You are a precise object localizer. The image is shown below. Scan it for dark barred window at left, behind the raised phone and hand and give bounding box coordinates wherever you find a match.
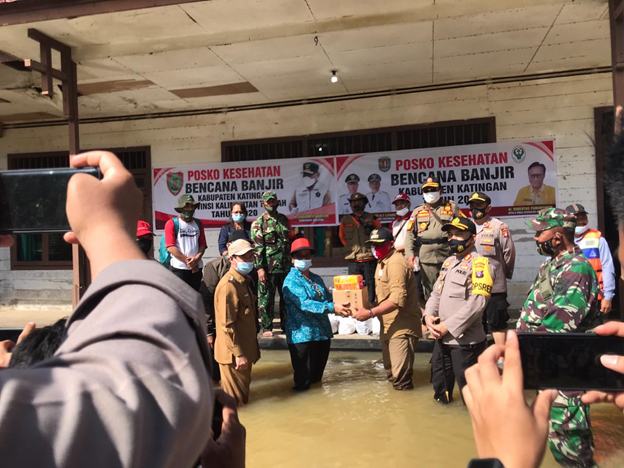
[8,148,152,270]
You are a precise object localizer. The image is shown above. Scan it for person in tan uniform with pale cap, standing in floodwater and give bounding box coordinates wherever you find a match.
[214,239,260,405]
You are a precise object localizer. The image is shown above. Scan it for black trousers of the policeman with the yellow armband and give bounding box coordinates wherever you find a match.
[431,340,486,403]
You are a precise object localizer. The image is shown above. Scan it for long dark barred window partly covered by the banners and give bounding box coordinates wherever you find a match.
[221,117,496,267]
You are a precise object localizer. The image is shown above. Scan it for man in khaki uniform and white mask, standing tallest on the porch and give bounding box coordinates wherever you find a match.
[405,177,459,301]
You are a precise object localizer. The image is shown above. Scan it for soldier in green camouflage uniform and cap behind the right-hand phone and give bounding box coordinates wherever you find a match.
[517,208,600,467]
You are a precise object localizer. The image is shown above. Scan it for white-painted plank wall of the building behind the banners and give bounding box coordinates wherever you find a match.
[0,74,613,308]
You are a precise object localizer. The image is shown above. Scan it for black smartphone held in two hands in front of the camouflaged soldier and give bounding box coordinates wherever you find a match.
[518,333,624,391]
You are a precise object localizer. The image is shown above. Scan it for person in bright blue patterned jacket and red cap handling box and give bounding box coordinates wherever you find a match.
[283,239,350,390]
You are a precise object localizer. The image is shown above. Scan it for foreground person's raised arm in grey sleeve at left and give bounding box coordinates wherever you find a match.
[0,151,213,467]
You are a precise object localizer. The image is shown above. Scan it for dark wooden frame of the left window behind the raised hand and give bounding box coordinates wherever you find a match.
[7,146,153,271]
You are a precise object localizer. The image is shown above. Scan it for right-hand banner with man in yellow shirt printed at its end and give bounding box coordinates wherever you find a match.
[336,140,557,222]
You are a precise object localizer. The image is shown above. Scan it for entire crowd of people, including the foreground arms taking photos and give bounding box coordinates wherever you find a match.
[0,134,624,468]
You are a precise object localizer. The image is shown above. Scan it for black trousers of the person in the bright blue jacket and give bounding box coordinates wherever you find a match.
[288,340,330,390]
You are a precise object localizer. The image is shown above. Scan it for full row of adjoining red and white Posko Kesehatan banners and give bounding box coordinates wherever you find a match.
[153,140,557,230]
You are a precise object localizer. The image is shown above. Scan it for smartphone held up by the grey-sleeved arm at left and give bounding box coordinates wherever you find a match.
[0,167,102,234]
